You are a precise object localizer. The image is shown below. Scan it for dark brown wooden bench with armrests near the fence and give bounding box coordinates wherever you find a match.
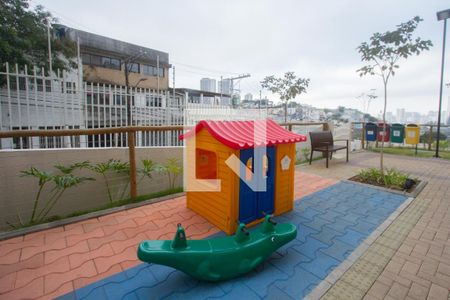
[309,131,348,168]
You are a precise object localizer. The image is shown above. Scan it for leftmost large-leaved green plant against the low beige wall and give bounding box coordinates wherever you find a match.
[18,162,94,226]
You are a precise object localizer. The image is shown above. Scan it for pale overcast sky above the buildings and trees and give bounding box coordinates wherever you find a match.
[31,0,450,114]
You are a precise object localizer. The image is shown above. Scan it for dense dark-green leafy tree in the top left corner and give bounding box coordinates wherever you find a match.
[0,0,76,70]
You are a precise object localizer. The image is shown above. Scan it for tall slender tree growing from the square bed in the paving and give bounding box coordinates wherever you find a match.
[356,16,433,174]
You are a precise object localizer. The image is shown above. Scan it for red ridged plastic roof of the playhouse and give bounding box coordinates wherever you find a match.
[180,119,306,149]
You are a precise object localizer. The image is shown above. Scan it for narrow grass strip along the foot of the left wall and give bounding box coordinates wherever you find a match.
[10,187,183,229]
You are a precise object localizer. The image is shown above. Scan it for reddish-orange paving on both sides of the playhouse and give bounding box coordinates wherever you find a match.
[0,172,336,299]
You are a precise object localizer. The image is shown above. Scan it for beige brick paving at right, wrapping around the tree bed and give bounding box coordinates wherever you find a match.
[302,152,450,300]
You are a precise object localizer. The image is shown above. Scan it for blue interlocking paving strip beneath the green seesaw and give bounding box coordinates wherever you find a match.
[59,182,406,300]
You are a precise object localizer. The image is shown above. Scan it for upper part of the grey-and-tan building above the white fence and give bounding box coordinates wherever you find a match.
[57,25,170,90]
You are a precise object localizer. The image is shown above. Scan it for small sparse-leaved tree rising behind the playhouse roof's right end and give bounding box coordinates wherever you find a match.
[261,72,309,122]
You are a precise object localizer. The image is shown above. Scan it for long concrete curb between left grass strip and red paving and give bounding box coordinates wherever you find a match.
[0,192,186,241]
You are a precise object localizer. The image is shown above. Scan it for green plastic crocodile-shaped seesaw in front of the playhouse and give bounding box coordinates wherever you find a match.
[137,215,297,281]
